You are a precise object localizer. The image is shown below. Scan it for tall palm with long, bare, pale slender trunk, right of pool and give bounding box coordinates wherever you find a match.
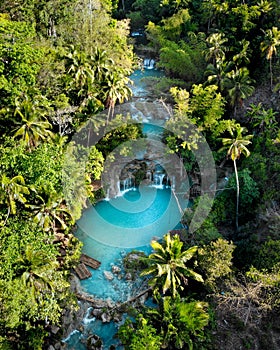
[222,125,253,230]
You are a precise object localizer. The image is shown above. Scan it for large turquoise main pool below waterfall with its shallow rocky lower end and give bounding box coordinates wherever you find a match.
[77,187,187,301]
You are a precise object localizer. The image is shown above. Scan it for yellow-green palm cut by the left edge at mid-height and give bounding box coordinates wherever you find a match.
[0,174,29,225]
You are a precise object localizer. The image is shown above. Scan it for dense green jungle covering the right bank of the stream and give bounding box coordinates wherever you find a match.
[116,0,280,350]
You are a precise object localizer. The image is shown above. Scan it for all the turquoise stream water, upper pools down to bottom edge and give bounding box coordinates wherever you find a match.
[64,61,188,350]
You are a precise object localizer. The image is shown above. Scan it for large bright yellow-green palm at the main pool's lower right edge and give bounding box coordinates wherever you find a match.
[141,233,203,297]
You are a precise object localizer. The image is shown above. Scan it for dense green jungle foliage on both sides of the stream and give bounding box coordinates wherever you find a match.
[0,0,280,350]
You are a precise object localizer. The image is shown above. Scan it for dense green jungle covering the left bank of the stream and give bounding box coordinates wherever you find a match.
[0,1,138,349]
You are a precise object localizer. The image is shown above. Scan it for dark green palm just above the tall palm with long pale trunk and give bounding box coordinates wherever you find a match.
[224,67,254,117]
